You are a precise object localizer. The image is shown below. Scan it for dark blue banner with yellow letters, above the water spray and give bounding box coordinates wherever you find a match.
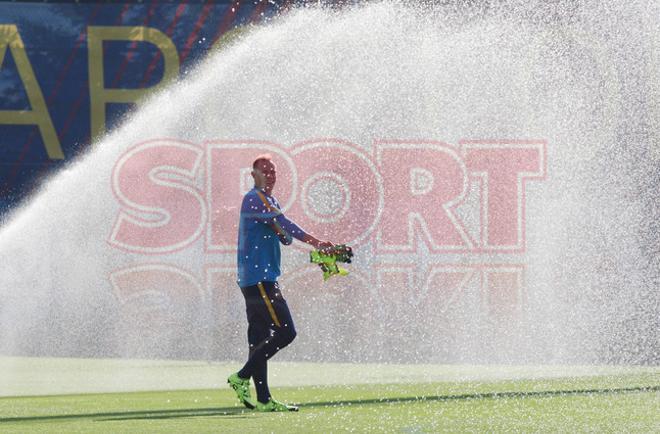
[0,1,287,215]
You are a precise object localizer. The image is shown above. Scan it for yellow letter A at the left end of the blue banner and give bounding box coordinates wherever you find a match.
[0,24,64,160]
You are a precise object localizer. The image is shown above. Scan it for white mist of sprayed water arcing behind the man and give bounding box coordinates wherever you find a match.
[0,0,660,364]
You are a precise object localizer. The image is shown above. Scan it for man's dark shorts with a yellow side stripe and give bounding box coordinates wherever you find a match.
[241,282,296,347]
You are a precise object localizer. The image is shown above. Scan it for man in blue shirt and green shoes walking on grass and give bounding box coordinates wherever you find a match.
[227,155,333,411]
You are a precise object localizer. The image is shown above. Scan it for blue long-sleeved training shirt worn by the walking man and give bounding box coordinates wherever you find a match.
[237,187,306,287]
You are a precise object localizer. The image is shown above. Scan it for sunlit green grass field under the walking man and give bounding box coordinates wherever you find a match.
[0,358,660,433]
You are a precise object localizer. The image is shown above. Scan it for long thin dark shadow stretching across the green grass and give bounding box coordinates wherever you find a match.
[0,386,660,424]
